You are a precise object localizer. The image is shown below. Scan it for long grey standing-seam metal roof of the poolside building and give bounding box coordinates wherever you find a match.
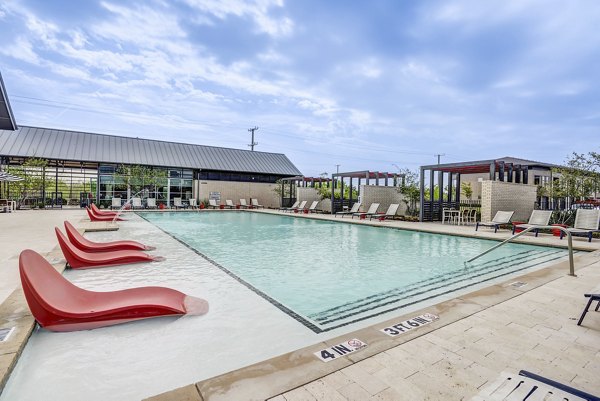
[0,126,302,176]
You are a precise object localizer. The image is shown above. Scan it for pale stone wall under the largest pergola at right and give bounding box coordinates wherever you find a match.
[481,180,537,221]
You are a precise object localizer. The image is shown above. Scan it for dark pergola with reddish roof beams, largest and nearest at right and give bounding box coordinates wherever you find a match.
[420,158,554,221]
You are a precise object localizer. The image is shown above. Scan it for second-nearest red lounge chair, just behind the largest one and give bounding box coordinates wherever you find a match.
[54,227,165,269]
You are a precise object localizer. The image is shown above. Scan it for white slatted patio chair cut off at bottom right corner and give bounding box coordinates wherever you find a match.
[471,370,600,401]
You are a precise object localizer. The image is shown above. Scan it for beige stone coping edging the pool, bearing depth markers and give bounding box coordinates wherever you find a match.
[145,211,600,401]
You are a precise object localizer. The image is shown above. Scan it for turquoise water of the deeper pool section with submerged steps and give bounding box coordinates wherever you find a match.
[142,212,567,333]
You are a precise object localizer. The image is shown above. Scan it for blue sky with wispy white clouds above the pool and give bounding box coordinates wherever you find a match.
[0,0,600,177]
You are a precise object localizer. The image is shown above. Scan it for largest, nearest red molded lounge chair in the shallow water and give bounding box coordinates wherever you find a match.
[19,249,208,331]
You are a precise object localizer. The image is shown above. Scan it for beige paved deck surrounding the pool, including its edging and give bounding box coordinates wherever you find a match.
[0,210,600,401]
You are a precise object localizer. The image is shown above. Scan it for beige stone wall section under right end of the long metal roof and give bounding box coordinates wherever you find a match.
[194,180,281,208]
